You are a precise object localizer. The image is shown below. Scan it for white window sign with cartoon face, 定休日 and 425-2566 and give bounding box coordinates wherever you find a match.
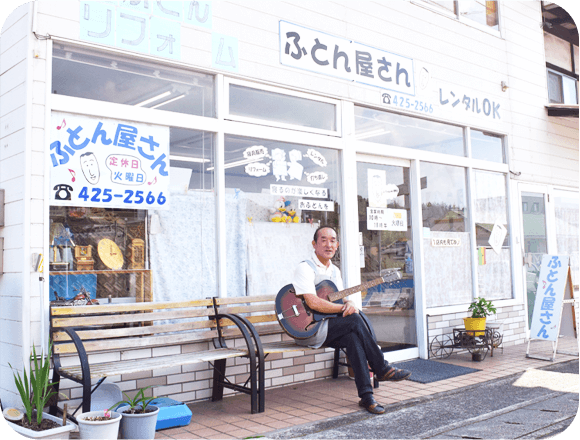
[50,112,169,209]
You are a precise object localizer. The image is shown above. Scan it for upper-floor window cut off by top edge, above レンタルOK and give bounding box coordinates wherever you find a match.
[415,0,499,30]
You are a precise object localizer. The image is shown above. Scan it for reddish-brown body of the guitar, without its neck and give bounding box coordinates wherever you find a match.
[276,280,342,339]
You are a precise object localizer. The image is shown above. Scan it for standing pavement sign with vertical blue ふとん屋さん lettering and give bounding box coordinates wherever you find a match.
[530,255,570,342]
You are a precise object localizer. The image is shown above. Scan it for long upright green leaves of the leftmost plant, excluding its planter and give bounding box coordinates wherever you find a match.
[8,341,56,425]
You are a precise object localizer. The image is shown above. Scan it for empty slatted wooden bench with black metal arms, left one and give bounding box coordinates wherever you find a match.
[50,299,264,414]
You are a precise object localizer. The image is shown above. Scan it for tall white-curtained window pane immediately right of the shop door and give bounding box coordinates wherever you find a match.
[421,162,473,307]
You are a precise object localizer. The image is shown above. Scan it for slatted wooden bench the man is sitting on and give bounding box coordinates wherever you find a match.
[213,295,379,412]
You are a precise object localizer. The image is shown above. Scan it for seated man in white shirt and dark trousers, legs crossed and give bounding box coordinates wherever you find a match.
[292,226,411,414]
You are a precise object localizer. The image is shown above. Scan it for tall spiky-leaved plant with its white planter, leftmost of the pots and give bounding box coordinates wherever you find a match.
[4,342,76,440]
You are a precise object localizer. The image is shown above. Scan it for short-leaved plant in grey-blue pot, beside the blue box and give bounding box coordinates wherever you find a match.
[111,386,159,440]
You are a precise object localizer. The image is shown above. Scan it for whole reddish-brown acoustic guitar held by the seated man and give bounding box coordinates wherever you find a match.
[276,269,402,339]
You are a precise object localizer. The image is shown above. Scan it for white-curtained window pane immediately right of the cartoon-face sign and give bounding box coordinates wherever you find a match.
[150,127,217,301]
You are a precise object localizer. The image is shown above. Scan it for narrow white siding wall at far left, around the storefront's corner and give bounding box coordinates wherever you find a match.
[0,4,31,405]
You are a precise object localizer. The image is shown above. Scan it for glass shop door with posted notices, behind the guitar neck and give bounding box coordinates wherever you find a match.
[357,156,418,360]
